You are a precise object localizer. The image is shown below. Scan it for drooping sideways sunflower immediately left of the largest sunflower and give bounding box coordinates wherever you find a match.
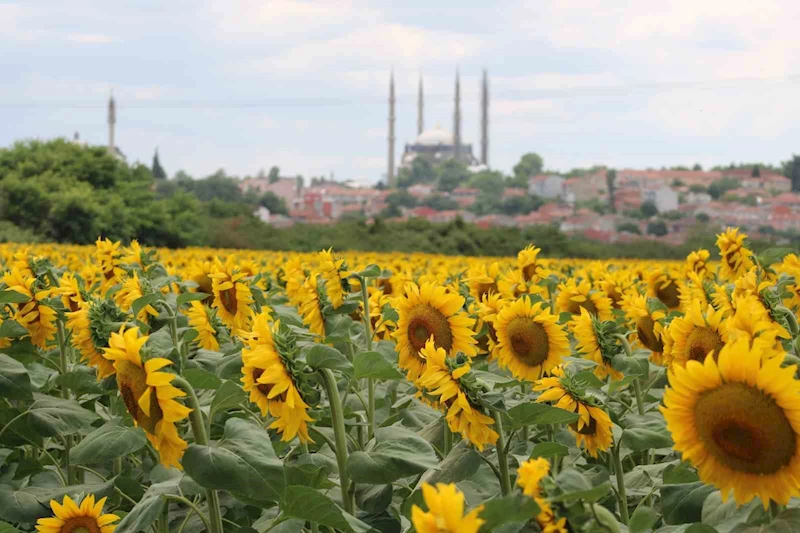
[533,366,613,458]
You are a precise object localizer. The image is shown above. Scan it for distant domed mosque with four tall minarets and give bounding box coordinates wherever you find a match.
[386,69,489,187]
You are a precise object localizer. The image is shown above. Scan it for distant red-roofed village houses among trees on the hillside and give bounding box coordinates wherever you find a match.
[240,165,800,244]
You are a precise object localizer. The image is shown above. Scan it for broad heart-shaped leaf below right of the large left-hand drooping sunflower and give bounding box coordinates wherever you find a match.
[183,418,286,502]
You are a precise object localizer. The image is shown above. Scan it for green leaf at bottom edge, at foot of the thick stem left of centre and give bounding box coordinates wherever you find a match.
[281,486,377,533]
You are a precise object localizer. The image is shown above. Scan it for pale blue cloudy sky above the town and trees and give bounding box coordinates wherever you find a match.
[0,0,800,183]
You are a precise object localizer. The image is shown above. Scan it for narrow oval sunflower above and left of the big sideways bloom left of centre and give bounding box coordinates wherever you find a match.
[211,258,253,335]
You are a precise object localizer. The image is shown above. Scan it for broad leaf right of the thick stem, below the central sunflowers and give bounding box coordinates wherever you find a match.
[347,426,439,485]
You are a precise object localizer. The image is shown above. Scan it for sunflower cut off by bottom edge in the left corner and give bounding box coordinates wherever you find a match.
[36,494,119,533]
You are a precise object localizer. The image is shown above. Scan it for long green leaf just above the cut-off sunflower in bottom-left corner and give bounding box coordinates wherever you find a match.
[0,478,114,524]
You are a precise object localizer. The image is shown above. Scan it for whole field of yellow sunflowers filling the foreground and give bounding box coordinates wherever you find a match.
[0,229,800,533]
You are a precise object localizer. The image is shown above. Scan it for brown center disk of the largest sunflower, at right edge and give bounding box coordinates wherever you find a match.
[694,383,796,475]
